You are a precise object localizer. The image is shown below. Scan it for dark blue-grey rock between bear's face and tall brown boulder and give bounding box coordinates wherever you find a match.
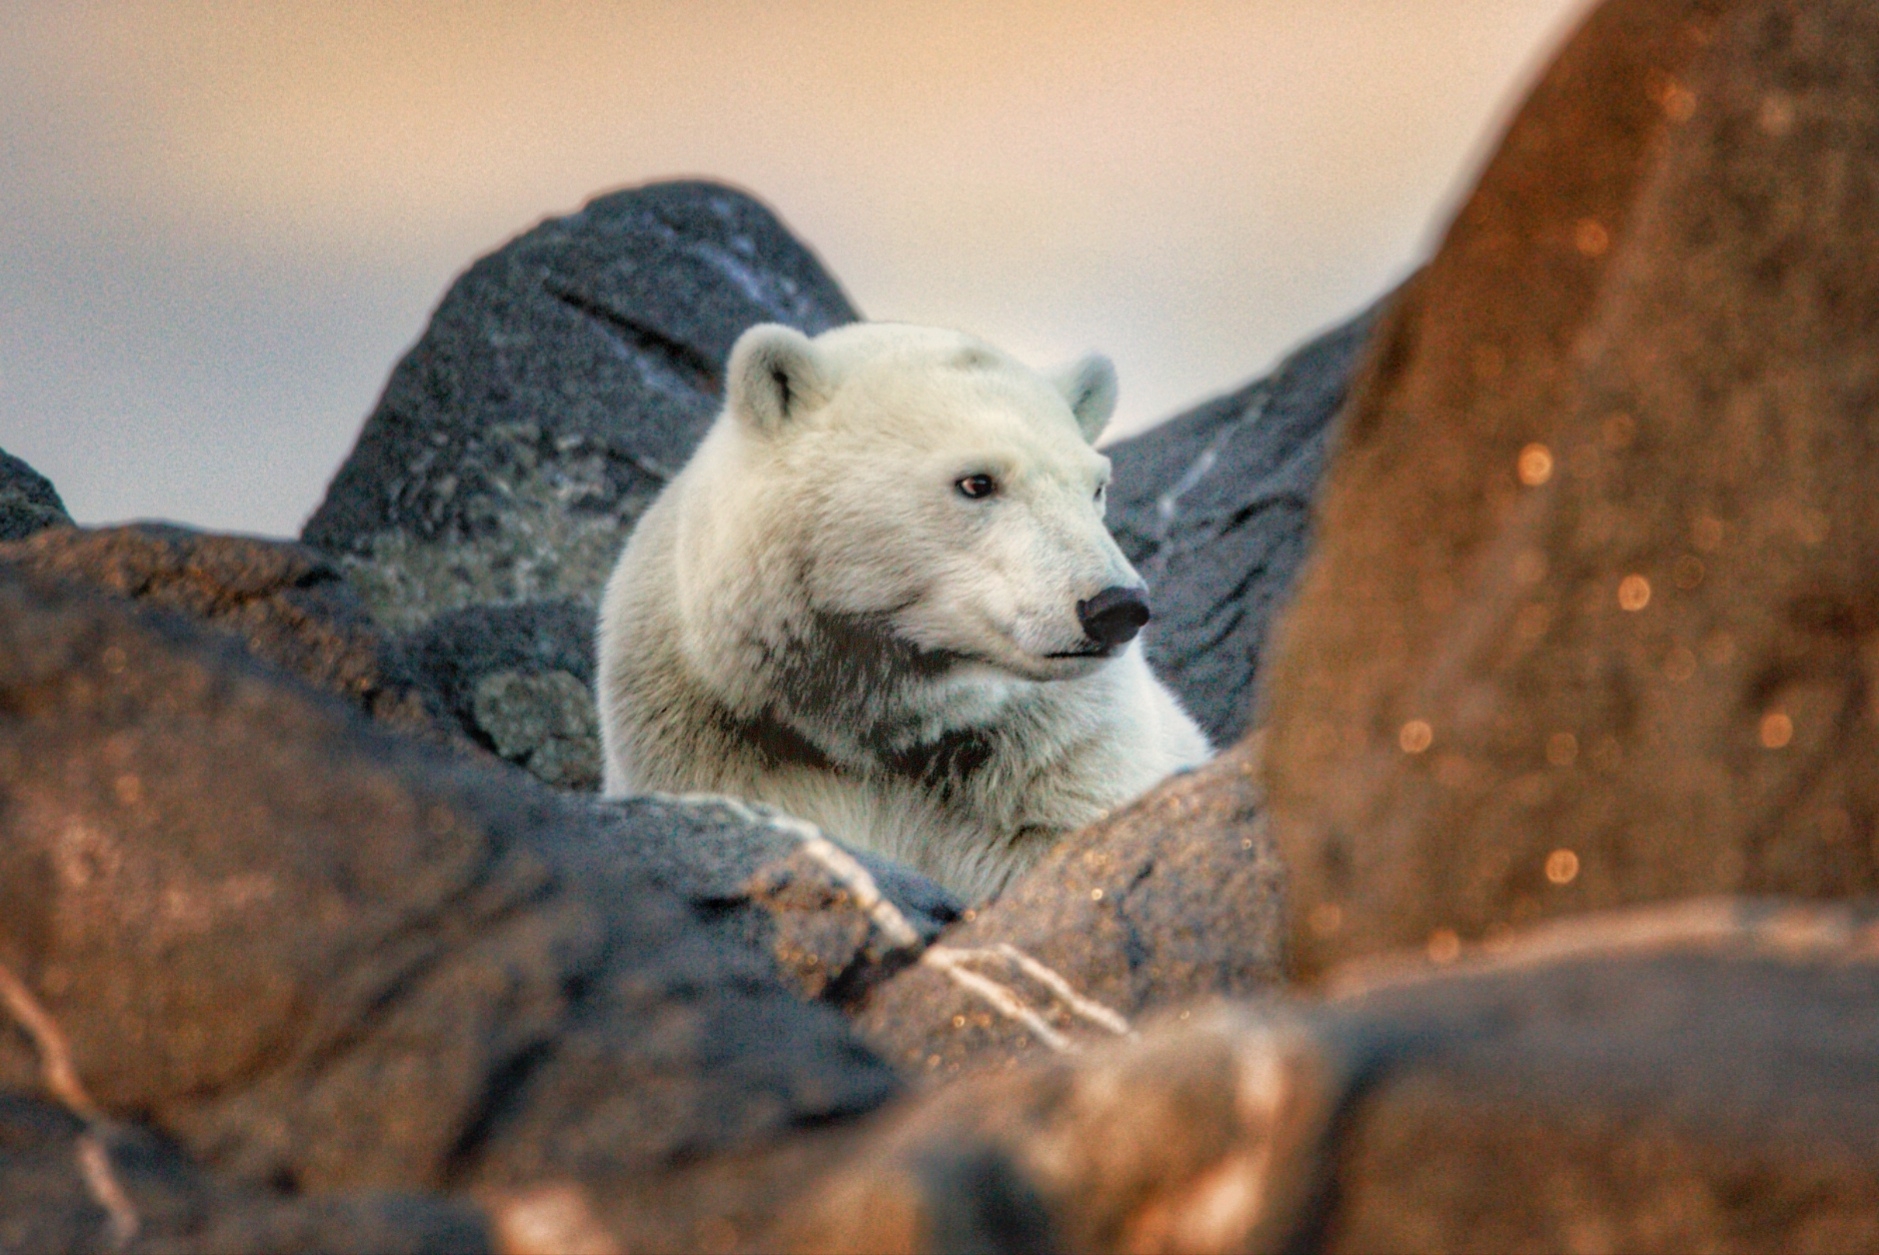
[1105,308,1377,746]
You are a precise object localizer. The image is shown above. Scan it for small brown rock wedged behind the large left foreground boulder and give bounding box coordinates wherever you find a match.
[0,522,451,740]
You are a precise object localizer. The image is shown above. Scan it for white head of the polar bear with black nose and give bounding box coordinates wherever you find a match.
[678,323,1148,751]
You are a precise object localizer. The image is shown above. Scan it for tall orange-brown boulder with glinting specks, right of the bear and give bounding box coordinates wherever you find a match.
[1265,0,1879,977]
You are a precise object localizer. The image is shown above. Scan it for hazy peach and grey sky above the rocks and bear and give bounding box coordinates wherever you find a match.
[0,0,1584,535]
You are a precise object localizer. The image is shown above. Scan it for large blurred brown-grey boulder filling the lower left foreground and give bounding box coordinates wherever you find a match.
[0,569,913,1249]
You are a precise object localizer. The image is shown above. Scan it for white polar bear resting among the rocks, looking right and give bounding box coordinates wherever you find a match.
[596,323,1210,900]
